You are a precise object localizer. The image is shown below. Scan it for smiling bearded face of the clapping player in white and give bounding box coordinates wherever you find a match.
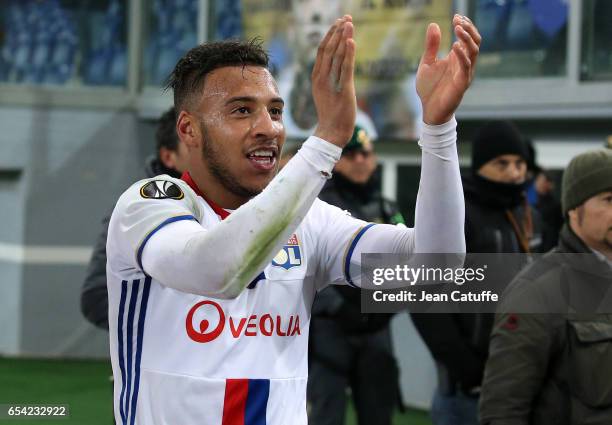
[198,66,285,199]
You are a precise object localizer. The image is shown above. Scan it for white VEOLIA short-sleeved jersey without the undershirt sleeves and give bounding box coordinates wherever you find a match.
[107,176,365,425]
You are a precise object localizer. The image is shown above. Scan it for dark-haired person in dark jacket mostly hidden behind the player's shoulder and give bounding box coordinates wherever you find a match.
[81,107,187,330]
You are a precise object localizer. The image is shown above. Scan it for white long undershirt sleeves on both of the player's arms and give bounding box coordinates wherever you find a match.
[142,114,465,298]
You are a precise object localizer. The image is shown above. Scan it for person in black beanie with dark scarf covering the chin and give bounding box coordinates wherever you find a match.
[412,121,542,425]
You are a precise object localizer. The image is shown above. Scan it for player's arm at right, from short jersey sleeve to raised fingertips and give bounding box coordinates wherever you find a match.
[314,15,481,286]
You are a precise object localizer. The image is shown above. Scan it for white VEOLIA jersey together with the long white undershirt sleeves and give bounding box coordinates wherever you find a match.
[107,120,465,425]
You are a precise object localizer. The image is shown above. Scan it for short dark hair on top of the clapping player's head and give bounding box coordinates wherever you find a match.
[166,38,269,111]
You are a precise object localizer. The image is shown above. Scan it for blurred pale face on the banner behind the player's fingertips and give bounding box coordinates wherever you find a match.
[291,0,342,61]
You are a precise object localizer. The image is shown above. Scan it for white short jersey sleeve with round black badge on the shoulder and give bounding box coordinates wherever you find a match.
[106,175,202,270]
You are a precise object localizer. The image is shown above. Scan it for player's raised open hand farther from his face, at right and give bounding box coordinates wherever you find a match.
[416,15,481,125]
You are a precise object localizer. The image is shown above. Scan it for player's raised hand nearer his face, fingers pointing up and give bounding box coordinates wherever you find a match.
[312,15,357,148]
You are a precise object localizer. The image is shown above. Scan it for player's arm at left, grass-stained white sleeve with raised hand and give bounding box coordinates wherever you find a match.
[114,16,356,298]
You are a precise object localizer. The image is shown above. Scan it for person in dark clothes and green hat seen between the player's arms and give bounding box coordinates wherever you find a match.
[307,125,404,425]
